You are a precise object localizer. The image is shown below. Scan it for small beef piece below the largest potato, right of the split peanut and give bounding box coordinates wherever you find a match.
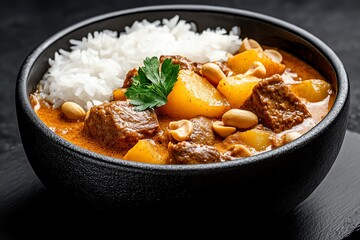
[189,116,215,145]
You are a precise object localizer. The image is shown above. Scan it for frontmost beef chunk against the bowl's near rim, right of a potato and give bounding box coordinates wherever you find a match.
[168,141,230,164]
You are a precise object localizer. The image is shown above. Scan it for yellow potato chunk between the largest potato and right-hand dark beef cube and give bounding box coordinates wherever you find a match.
[217,74,260,108]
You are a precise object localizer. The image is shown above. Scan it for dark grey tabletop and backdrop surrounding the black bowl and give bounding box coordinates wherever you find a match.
[0,0,360,239]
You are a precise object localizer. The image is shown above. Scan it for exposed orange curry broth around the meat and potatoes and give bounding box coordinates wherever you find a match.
[36,50,335,161]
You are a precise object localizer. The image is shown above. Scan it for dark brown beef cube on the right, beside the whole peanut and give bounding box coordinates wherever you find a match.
[240,74,311,133]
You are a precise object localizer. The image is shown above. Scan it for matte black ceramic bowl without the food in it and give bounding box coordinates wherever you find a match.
[16,5,349,213]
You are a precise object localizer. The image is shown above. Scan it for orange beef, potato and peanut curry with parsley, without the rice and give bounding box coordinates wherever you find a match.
[30,15,336,164]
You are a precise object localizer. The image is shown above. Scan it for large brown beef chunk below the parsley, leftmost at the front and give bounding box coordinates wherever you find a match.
[84,101,159,149]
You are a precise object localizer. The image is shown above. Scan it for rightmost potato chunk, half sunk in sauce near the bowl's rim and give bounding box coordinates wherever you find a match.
[289,79,332,102]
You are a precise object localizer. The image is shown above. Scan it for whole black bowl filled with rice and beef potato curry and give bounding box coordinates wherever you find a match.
[16,5,349,212]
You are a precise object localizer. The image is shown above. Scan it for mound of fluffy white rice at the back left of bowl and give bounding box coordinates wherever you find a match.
[37,16,241,110]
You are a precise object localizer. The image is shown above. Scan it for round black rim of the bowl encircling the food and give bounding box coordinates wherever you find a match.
[16,4,349,172]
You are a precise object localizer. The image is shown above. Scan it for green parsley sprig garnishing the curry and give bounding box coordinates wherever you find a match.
[125,57,180,111]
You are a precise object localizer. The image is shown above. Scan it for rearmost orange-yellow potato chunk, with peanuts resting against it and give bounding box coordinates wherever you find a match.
[228,49,285,77]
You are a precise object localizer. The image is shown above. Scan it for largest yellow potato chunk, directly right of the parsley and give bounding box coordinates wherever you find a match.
[158,70,230,119]
